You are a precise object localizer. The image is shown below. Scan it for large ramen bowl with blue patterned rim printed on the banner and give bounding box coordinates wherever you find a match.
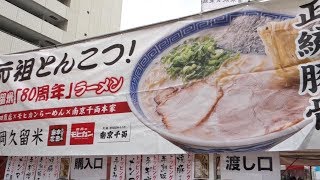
[128,11,310,152]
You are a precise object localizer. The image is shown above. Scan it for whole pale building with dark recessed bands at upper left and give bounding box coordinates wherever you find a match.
[0,0,122,54]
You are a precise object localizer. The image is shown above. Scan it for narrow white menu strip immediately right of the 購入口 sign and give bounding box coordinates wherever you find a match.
[110,156,126,180]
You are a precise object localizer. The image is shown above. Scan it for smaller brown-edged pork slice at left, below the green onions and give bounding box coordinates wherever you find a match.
[157,81,222,132]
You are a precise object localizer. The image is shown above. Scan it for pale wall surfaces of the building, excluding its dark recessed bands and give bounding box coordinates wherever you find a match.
[0,0,122,53]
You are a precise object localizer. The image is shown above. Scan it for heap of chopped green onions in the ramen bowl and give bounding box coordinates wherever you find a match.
[161,37,237,82]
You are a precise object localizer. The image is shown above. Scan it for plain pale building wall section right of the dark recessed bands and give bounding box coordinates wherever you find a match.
[68,0,122,40]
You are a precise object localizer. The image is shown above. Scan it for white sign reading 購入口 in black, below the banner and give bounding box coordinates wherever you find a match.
[70,156,107,180]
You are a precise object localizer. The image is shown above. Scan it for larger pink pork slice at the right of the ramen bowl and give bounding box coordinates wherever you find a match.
[208,71,309,140]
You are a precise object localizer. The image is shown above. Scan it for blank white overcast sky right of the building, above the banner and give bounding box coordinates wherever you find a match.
[121,0,201,30]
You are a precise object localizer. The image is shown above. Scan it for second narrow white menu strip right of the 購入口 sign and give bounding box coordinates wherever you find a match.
[126,155,141,180]
